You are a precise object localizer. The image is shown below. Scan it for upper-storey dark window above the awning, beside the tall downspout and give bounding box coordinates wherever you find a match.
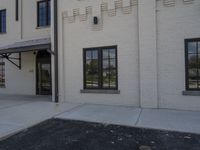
[37,0,51,27]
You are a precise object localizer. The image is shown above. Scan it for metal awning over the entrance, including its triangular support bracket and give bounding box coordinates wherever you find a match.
[0,38,54,69]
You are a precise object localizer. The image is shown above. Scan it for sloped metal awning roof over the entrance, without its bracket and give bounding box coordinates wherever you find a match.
[0,38,51,54]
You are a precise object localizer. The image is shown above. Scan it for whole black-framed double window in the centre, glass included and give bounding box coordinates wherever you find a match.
[83,46,118,89]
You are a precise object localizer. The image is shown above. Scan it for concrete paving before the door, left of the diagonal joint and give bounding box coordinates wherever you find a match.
[0,96,80,140]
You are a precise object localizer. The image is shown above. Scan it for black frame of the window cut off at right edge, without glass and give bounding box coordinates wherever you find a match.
[185,38,200,91]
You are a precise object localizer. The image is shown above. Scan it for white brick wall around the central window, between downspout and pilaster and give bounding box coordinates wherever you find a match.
[59,0,139,106]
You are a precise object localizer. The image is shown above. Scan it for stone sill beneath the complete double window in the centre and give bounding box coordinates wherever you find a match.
[80,89,120,94]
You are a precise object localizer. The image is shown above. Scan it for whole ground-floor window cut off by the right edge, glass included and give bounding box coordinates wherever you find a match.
[185,39,200,91]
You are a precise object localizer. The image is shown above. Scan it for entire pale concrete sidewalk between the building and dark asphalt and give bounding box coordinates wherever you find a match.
[0,96,200,140]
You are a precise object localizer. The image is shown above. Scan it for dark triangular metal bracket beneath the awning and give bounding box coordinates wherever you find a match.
[0,52,22,70]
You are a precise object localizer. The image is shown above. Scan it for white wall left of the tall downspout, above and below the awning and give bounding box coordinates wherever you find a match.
[0,0,51,95]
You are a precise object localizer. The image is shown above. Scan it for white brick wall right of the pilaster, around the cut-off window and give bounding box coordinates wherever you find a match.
[157,0,200,110]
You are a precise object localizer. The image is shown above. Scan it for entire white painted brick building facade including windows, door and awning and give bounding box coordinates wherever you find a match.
[0,0,200,110]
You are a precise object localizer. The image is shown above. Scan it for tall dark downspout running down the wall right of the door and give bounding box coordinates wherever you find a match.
[53,0,59,103]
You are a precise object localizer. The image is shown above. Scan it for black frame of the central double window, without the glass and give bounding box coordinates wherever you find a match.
[83,45,118,90]
